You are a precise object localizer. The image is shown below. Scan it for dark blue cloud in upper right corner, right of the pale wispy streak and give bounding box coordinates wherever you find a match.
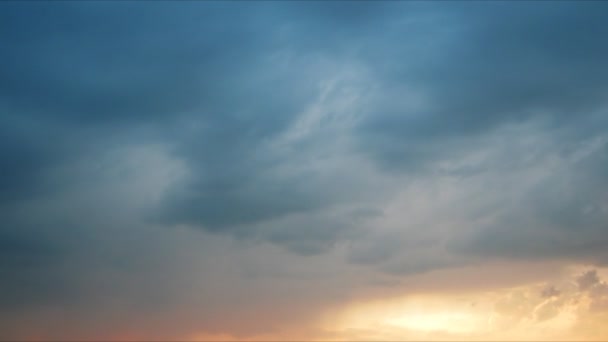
[354,3,608,169]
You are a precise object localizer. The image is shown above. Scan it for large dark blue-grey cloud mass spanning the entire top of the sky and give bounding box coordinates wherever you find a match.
[3,4,606,256]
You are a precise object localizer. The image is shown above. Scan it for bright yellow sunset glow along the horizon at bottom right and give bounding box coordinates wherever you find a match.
[326,268,608,341]
